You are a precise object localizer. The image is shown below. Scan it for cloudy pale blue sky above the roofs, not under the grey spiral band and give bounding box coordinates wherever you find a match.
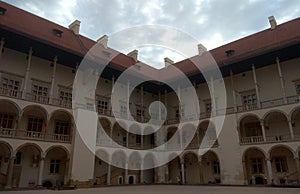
[5,0,300,68]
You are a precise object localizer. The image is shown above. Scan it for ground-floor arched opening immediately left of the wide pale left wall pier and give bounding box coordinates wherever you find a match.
[42,147,69,186]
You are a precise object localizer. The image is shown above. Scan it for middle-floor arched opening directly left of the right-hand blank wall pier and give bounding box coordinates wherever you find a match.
[198,121,218,148]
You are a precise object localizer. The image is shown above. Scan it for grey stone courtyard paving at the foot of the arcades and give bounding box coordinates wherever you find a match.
[0,185,300,194]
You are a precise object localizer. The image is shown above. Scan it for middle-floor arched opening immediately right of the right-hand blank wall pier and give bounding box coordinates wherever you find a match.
[239,115,264,144]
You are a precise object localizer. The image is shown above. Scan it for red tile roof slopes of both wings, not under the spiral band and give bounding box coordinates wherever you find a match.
[0,2,300,77]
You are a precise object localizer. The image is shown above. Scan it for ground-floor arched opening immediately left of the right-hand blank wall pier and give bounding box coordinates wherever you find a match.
[201,151,221,184]
